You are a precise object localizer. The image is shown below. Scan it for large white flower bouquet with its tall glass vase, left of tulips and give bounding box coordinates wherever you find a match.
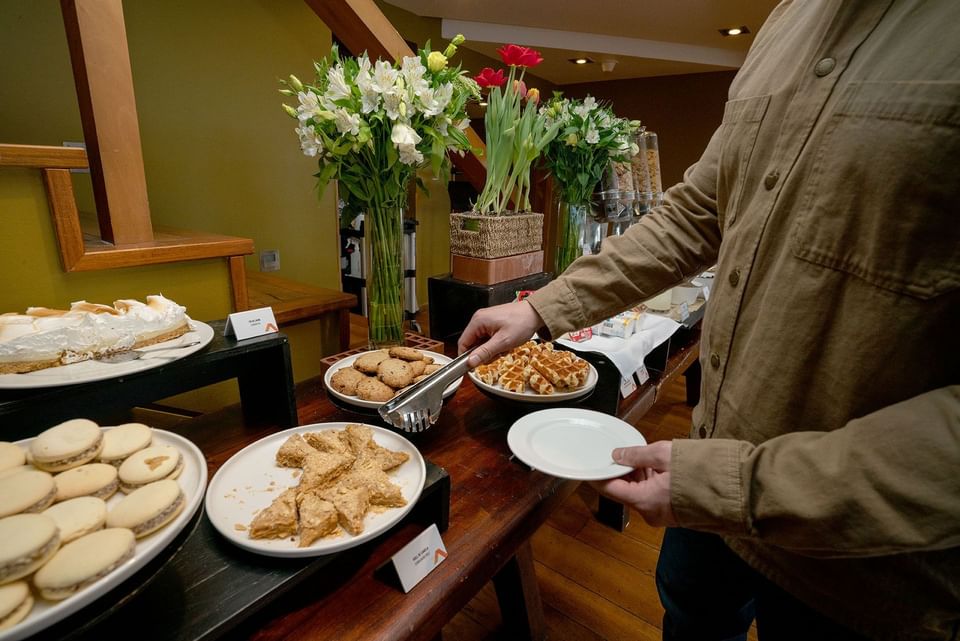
[281,36,480,346]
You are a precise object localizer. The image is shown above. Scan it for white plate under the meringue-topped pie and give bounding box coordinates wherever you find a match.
[0,320,213,389]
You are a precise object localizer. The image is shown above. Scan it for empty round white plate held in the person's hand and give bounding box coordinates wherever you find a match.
[507,407,647,481]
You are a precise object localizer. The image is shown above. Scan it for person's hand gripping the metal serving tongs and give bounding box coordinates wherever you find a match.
[457,301,543,367]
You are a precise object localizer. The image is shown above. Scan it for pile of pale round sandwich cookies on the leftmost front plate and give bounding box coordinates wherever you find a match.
[0,419,186,630]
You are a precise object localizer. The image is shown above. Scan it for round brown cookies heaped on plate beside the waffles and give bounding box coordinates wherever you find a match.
[330,347,442,403]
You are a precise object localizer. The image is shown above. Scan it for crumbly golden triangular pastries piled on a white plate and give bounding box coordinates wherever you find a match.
[249,424,410,547]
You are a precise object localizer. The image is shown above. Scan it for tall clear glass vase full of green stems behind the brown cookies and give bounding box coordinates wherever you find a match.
[363,205,404,349]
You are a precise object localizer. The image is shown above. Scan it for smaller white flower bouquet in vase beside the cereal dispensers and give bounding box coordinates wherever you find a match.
[540,93,640,274]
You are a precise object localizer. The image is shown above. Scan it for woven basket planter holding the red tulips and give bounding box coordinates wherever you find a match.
[450,213,543,258]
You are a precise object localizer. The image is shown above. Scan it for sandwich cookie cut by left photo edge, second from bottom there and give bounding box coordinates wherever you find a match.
[0,514,60,585]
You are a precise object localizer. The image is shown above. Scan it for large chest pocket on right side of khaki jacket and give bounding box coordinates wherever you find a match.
[790,82,960,299]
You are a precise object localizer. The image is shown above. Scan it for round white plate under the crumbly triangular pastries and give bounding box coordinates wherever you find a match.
[206,423,427,557]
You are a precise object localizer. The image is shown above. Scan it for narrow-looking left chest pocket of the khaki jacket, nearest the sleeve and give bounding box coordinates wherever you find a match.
[717,95,770,231]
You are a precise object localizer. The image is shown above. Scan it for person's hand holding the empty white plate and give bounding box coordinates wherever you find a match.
[591,441,677,527]
